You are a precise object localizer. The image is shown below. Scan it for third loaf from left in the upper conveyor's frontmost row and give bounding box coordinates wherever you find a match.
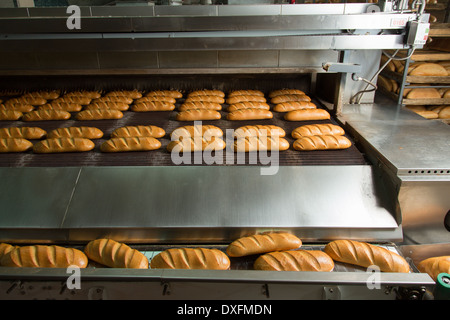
[100,137,161,152]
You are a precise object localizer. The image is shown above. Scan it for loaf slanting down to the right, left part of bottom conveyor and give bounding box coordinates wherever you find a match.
[84,239,148,269]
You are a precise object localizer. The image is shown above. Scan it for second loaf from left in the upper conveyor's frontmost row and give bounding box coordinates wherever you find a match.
[33,138,95,153]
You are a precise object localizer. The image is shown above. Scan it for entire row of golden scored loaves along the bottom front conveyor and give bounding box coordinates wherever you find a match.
[0,232,450,280]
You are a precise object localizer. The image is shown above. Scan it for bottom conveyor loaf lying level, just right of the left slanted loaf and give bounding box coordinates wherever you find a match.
[150,248,230,270]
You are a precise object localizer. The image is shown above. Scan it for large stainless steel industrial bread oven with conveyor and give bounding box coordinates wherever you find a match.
[0,1,450,299]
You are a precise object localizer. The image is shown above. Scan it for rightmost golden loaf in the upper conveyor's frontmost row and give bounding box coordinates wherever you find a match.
[292,135,352,151]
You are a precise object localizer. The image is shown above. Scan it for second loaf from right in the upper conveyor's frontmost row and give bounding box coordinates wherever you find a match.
[234,136,289,152]
